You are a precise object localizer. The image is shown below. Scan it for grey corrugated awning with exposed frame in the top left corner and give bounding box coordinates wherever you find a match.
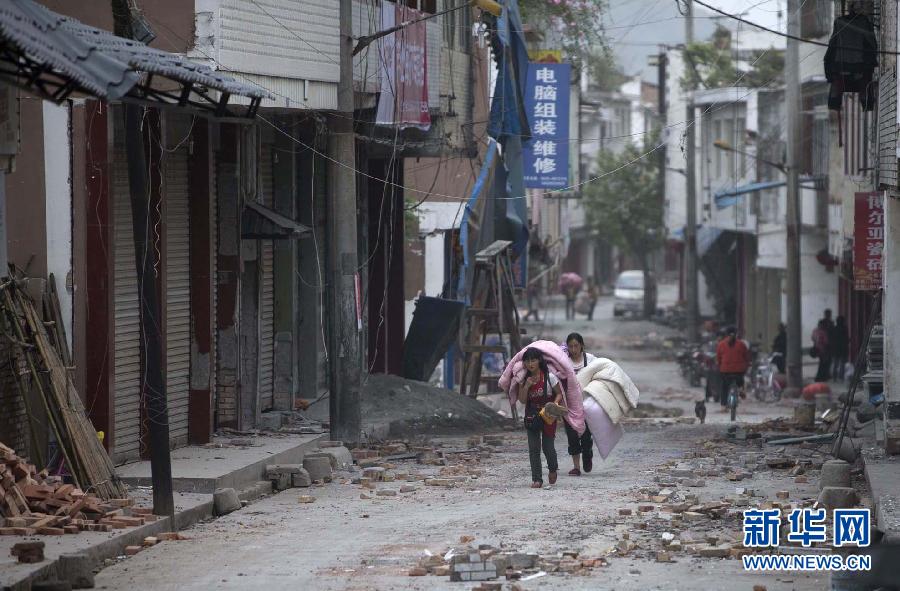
[0,0,269,117]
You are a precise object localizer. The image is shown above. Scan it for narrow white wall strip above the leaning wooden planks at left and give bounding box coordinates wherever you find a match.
[44,101,72,350]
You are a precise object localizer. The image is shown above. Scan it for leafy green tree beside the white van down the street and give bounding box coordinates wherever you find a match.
[583,134,664,316]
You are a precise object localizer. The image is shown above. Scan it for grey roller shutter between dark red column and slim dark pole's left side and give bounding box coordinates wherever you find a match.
[112,146,141,464]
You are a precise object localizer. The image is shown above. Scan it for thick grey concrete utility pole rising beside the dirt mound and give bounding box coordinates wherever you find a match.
[328,0,362,442]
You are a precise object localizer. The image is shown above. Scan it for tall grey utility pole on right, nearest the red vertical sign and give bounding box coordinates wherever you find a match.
[784,0,803,389]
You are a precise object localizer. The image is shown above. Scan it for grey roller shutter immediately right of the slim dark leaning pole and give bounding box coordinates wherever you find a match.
[163,148,191,447]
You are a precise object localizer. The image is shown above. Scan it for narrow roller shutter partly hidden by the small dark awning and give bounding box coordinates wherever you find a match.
[259,144,275,410]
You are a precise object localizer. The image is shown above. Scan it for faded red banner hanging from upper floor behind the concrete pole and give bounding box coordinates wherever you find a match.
[376,2,431,130]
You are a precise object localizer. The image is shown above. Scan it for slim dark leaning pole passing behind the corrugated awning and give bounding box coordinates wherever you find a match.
[112,0,175,518]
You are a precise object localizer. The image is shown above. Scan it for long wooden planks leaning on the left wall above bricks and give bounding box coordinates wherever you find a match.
[0,280,125,499]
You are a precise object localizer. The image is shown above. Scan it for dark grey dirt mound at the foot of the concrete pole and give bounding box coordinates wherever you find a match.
[362,375,513,439]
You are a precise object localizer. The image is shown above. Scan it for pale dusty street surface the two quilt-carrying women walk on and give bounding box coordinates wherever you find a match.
[89,298,828,591]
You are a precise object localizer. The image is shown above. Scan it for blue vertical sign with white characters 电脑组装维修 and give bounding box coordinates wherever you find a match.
[523,62,572,189]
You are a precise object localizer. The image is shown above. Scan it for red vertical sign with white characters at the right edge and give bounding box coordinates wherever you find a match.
[853,191,884,291]
